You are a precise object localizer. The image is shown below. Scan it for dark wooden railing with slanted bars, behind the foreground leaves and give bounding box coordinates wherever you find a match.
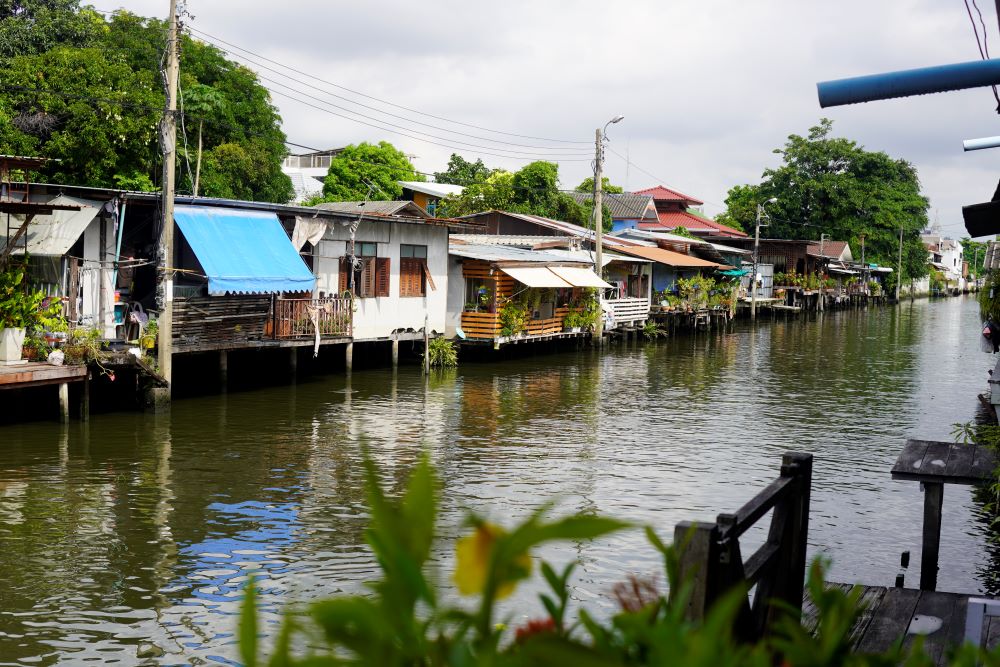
[671,453,812,641]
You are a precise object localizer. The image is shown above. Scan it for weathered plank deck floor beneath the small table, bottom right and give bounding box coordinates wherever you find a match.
[802,582,1000,665]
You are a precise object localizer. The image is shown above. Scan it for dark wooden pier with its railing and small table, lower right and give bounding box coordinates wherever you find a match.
[674,440,1000,665]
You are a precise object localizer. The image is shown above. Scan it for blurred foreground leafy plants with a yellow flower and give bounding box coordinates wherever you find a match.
[239,455,1000,667]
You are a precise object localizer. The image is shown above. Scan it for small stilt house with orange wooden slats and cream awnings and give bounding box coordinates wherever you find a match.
[448,240,612,347]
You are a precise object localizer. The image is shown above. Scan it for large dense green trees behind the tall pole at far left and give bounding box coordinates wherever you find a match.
[0,0,292,202]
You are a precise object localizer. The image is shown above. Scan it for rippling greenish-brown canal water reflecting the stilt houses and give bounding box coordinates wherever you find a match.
[0,297,997,665]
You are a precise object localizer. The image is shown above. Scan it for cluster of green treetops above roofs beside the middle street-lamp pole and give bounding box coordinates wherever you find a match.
[442,160,611,231]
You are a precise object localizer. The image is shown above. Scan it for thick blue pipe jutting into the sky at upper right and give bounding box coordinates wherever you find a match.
[816,59,1000,108]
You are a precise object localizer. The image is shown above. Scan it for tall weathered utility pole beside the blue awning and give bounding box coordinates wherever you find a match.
[155,0,180,404]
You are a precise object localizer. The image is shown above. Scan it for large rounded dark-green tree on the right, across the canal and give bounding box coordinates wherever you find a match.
[718,118,929,279]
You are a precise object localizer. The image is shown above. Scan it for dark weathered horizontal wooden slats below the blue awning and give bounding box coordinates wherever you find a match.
[174,295,271,352]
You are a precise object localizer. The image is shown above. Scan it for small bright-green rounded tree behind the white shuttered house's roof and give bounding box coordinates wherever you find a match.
[320,141,424,201]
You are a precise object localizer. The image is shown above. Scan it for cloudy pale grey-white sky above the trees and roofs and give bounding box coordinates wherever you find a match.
[92,0,1000,237]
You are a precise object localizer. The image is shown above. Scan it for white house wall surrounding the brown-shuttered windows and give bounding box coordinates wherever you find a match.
[313,221,448,340]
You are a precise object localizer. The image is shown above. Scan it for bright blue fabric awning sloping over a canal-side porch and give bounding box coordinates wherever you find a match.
[174,206,316,294]
